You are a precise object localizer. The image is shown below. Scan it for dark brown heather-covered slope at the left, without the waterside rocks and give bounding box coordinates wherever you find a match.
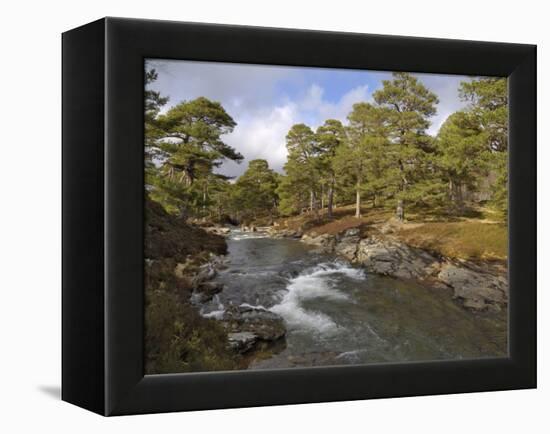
[145,200,237,374]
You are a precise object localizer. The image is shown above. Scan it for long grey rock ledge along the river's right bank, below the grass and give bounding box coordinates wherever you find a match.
[301,228,508,310]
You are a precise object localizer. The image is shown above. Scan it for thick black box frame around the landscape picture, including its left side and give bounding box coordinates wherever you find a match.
[62,18,536,415]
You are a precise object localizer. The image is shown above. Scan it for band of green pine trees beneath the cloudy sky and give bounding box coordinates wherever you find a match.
[145,69,508,225]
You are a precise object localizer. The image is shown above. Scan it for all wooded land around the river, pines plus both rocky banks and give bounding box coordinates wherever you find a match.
[145,70,508,374]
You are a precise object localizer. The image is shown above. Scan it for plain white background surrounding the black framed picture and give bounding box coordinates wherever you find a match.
[0,0,550,434]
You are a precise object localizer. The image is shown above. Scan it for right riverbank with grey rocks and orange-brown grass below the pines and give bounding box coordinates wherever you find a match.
[260,208,508,311]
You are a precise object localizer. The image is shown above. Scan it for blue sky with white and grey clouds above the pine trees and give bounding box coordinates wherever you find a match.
[146,59,469,177]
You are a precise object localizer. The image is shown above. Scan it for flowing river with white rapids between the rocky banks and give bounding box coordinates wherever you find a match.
[202,231,507,369]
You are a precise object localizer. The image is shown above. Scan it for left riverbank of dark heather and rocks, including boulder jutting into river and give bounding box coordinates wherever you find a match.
[145,200,286,374]
